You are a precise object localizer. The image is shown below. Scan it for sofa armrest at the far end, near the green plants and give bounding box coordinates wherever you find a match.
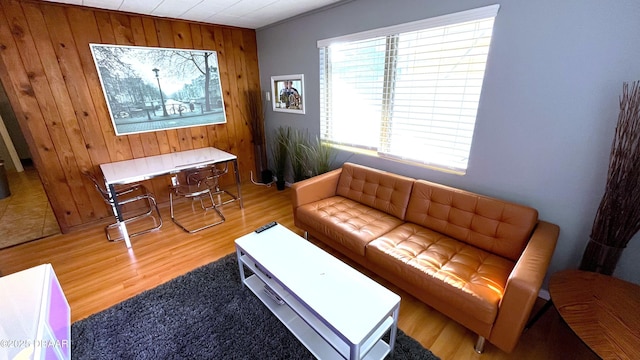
[291,168,342,210]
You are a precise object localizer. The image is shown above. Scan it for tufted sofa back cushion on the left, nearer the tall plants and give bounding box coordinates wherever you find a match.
[336,163,415,220]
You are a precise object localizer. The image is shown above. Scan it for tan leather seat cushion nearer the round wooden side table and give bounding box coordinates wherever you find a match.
[366,223,515,324]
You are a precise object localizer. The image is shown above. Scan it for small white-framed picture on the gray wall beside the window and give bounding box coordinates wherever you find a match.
[271,74,306,114]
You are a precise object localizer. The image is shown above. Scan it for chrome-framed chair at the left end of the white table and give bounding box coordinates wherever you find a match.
[82,171,162,241]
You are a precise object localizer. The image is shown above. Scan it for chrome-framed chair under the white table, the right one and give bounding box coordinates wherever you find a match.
[169,168,225,234]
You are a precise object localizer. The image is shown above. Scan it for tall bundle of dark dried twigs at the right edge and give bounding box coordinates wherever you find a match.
[580,81,640,275]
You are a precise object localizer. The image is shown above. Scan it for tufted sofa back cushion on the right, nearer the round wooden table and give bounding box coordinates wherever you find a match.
[406,180,538,261]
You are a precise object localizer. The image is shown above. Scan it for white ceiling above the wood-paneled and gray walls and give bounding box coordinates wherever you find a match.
[45,0,342,29]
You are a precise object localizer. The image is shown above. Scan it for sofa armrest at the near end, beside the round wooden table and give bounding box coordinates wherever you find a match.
[489,221,560,352]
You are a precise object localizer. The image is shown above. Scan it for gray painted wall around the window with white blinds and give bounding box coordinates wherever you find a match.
[257,0,640,283]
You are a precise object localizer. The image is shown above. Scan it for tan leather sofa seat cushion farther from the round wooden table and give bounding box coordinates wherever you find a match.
[296,196,402,256]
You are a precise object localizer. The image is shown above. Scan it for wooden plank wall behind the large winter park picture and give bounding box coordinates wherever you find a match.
[0,0,260,232]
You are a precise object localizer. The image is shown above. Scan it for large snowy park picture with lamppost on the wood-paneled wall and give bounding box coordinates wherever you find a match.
[89,44,227,135]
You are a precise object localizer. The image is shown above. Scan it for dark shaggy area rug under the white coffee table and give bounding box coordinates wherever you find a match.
[71,254,438,360]
